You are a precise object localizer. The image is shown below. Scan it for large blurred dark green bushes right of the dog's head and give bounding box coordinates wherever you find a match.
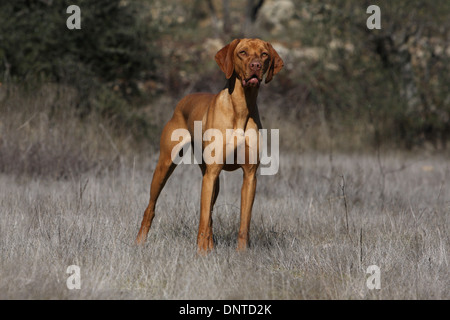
[281,0,450,148]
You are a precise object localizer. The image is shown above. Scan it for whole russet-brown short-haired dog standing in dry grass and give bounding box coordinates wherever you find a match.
[136,39,283,252]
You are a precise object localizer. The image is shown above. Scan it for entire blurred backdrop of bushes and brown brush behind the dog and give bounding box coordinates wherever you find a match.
[0,0,450,179]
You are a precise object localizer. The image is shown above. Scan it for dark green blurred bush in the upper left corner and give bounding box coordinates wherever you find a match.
[0,0,157,106]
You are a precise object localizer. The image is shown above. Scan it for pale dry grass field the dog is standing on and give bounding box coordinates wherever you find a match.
[0,152,450,299]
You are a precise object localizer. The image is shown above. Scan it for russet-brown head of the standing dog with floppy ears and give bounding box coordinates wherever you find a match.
[215,39,284,87]
